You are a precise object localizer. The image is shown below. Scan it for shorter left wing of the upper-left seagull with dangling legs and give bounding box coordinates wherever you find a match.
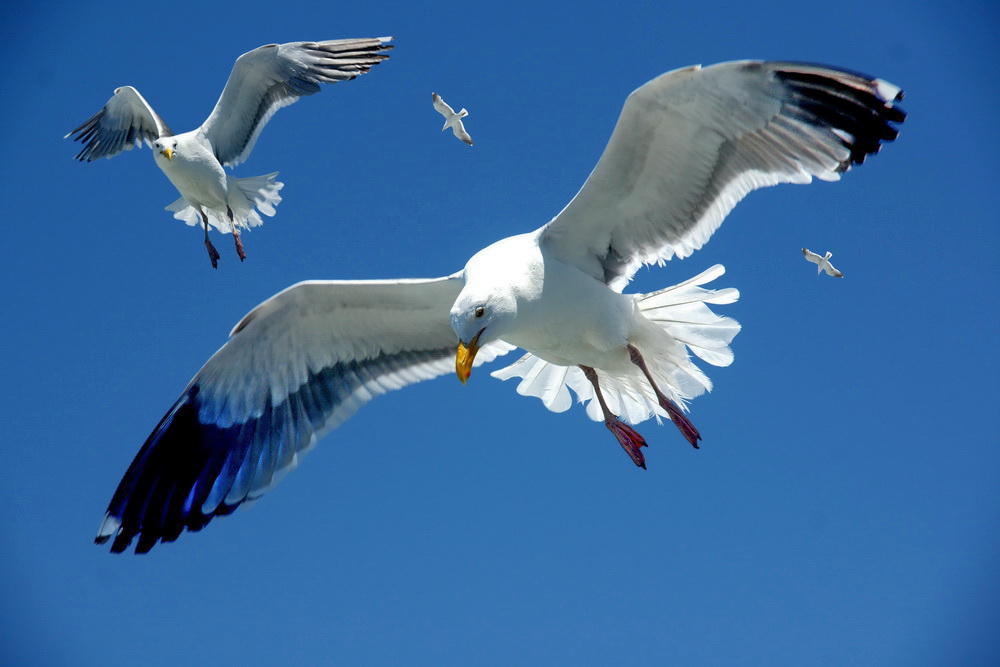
[63,86,173,162]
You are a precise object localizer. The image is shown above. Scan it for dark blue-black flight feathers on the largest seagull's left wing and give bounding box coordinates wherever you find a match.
[97,345,455,553]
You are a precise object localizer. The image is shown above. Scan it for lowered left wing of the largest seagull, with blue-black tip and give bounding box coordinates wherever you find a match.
[96,277,511,553]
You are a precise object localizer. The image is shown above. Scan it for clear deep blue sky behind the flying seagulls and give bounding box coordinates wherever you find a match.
[0,0,1000,666]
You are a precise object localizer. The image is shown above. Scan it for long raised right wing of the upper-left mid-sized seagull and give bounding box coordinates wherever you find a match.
[200,37,392,166]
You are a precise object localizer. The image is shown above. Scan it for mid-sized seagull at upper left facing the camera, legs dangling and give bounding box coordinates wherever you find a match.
[66,37,392,268]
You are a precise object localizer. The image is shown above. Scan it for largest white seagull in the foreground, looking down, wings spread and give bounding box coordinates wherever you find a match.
[96,61,906,553]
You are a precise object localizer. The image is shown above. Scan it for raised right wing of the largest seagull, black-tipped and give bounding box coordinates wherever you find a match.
[540,61,906,289]
